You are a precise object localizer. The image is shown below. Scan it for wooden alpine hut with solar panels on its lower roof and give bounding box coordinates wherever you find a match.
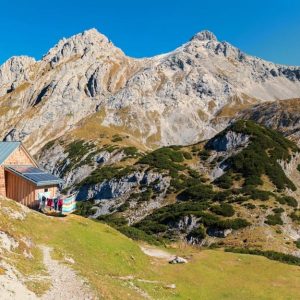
[0,142,63,208]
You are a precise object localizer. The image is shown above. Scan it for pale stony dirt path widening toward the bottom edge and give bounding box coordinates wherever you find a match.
[41,246,97,300]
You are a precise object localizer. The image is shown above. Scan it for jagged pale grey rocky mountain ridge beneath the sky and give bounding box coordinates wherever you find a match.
[0,29,300,152]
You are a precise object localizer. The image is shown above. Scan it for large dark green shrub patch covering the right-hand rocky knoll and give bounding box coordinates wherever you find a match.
[206,120,299,191]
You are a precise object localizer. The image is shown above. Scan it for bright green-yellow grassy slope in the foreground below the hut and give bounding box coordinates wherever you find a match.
[0,199,300,299]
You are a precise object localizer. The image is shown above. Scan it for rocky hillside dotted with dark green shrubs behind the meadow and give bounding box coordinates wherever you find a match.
[38,116,300,255]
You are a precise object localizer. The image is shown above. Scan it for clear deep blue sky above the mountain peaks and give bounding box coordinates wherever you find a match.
[0,0,300,65]
